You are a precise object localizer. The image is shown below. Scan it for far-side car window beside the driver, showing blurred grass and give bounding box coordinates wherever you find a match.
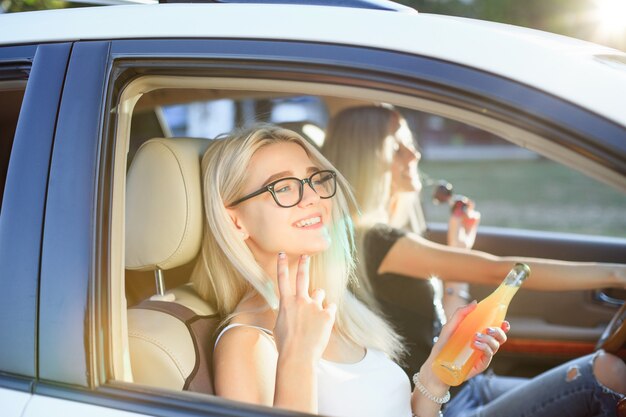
[413,113,626,237]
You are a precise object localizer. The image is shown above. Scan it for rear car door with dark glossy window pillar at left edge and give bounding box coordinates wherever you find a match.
[0,44,70,416]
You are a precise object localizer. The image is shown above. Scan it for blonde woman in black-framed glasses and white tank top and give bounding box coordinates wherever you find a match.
[193,126,626,417]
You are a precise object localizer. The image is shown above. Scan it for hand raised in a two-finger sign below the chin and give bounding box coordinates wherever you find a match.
[274,252,337,361]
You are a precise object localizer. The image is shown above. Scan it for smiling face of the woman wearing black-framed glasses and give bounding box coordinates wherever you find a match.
[228,142,332,262]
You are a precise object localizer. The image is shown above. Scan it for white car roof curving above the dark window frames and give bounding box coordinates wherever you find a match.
[0,4,626,126]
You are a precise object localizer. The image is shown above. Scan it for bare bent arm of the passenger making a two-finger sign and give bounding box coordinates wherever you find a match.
[214,253,336,414]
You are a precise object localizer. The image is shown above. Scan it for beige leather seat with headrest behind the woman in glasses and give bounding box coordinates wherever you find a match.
[126,138,219,394]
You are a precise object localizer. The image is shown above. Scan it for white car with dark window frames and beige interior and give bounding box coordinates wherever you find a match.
[0,0,626,417]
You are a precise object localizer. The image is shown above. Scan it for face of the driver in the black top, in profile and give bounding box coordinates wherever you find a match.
[388,122,422,193]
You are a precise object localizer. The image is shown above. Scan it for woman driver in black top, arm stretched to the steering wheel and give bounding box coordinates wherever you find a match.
[322,106,626,373]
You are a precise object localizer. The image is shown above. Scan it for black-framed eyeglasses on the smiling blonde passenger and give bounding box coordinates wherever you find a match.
[229,170,337,208]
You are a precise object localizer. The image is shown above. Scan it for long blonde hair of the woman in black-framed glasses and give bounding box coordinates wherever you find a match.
[192,125,404,359]
